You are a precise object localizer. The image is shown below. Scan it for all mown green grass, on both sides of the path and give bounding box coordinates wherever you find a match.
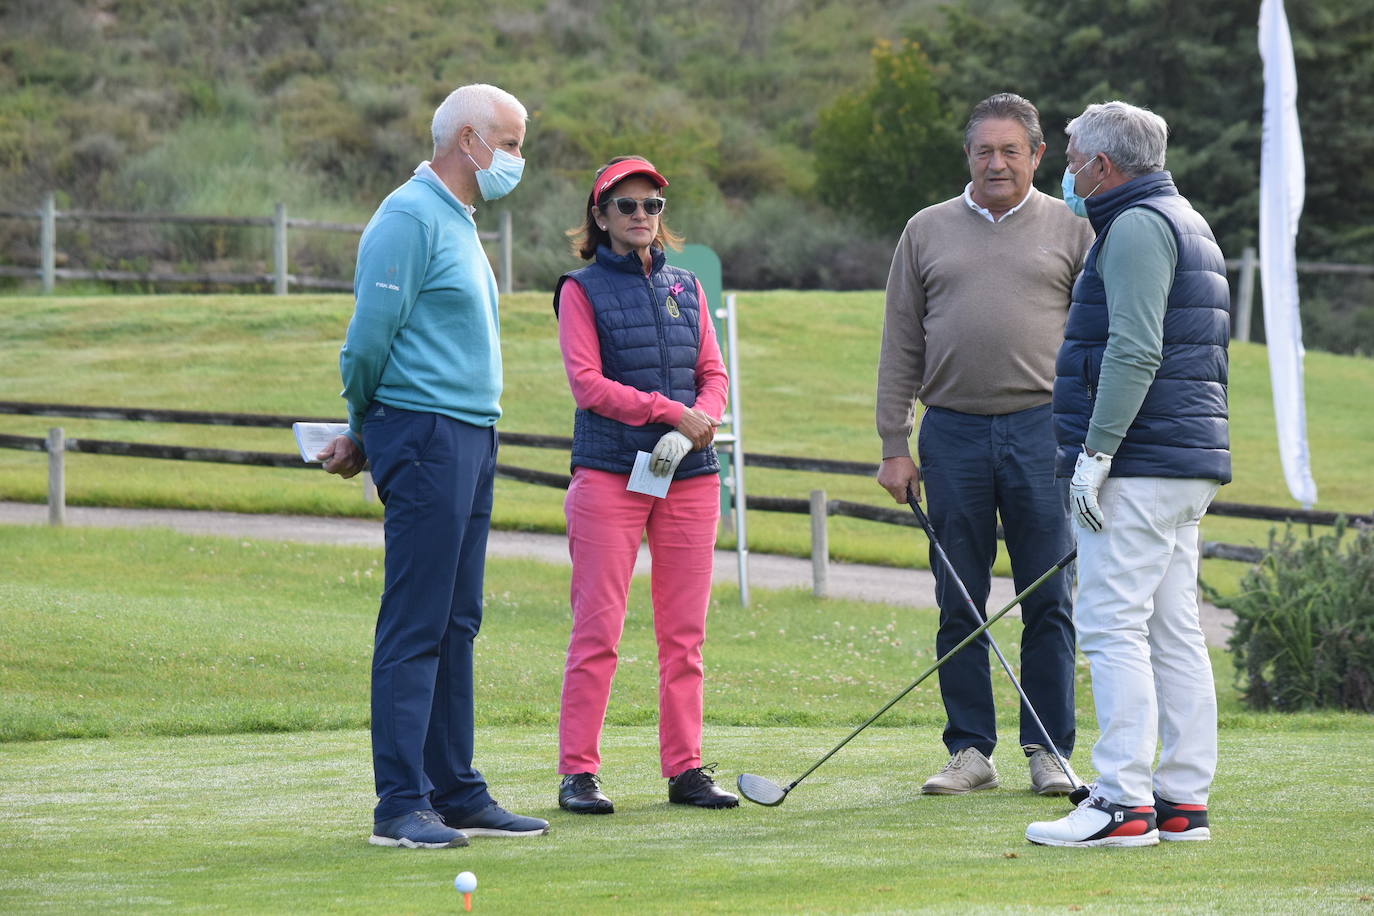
[0,293,1374,913]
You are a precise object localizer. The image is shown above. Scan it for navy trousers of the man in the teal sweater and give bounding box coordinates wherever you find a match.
[363,404,496,821]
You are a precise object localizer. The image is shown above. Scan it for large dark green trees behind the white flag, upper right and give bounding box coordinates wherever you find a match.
[911,0,1374,269]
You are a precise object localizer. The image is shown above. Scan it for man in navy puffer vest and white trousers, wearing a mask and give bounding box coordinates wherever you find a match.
[1026,102,1231,846]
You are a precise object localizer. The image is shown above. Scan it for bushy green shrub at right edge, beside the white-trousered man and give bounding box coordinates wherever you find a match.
[1212,522,1374,711]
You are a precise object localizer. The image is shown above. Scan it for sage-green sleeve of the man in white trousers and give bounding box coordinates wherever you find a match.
[1083,207,1179,455]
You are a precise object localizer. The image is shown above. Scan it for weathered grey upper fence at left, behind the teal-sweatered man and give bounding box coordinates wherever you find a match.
[0,191,515,295]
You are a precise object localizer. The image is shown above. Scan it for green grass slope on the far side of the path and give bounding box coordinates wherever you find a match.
[0,293,1374,591]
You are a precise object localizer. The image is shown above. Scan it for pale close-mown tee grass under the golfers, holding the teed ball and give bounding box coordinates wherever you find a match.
[8,726,1374,915]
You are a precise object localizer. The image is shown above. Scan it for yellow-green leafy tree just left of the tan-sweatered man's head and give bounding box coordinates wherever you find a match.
[813,41,966,236]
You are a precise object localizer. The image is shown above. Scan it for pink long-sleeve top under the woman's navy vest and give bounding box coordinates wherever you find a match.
[558,280,730,427]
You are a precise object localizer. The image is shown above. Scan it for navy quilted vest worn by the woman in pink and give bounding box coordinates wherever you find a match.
[554,246,720,479]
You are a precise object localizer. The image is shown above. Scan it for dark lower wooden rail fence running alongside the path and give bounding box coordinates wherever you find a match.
[8,401,1374,582]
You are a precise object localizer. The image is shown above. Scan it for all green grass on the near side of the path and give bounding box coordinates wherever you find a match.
[0,526,1374,913]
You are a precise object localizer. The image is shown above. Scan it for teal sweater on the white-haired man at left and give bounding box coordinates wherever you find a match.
[339,163,502,450]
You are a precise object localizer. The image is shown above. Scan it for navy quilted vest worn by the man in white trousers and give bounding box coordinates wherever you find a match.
[1054,172,1231,483]
